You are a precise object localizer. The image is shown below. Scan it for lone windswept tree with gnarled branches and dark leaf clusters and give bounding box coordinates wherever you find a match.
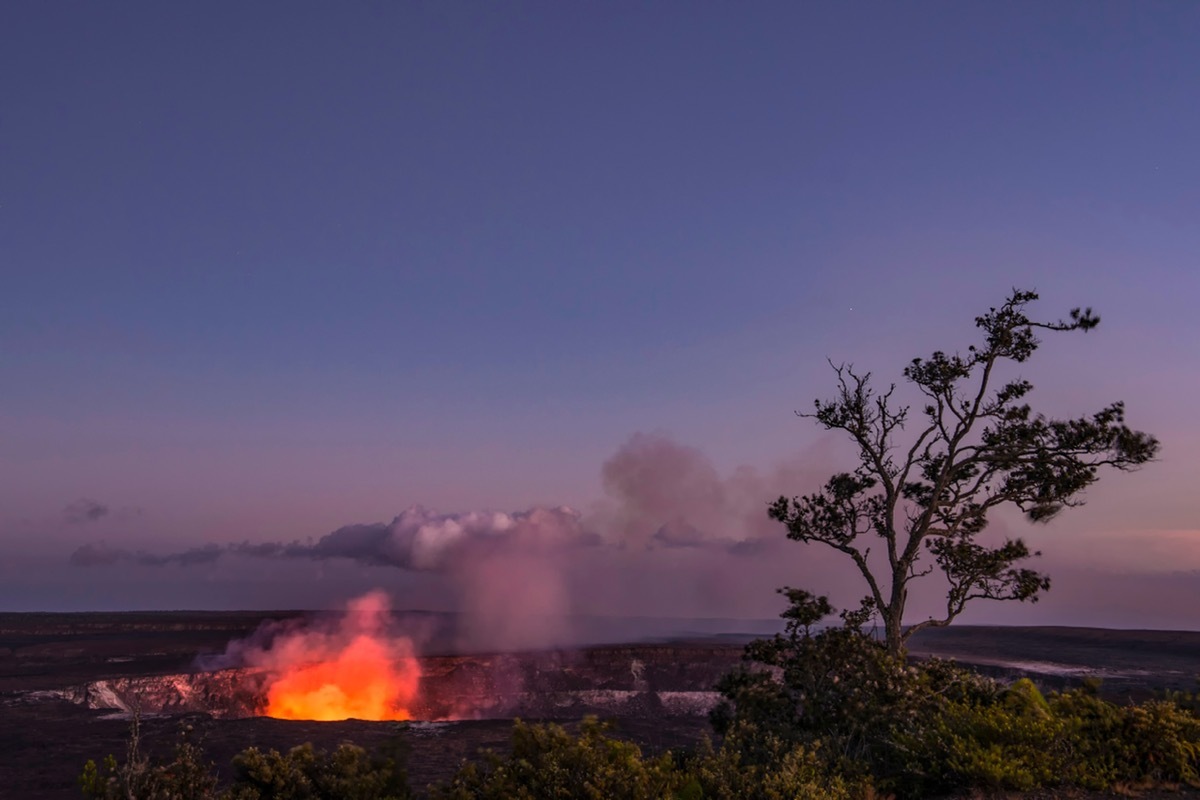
[769,290,1158,655]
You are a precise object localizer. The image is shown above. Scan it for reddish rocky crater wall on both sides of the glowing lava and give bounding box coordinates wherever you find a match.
[55,644,739,721]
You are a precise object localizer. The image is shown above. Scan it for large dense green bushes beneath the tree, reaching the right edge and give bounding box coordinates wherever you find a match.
[713,589,1200,798]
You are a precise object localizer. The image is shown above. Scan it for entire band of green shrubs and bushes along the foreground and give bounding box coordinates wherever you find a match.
[79,599,1200,800]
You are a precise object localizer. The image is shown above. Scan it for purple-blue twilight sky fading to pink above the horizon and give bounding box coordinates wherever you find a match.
[0,1,1200,627]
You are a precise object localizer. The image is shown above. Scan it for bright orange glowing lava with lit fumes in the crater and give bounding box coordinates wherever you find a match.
[255,593,421,721]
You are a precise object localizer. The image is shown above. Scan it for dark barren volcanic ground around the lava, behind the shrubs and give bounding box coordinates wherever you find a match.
[0,612,1200,798]
